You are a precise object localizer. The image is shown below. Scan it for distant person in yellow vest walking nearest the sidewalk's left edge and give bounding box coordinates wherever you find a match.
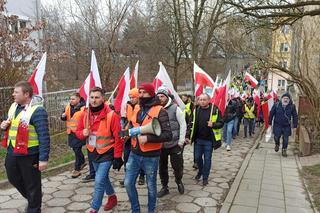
[243,99,256,138]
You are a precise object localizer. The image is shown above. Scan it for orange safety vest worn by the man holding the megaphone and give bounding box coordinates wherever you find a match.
[131,105,162,152]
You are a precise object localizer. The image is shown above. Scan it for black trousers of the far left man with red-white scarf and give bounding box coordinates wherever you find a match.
[5,154,42,213]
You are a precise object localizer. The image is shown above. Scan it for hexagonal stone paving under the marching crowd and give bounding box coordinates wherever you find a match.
[0,131,253,213]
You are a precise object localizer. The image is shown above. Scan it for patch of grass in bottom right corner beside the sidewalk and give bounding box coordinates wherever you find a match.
[302,164,320,211]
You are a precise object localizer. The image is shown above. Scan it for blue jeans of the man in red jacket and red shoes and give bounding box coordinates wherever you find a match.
[91,161,114,211]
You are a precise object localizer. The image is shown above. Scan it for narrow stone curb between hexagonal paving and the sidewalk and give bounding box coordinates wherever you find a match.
[219,130,264,213]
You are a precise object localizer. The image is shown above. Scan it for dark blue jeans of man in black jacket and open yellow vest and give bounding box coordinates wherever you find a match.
[194,139,213,180]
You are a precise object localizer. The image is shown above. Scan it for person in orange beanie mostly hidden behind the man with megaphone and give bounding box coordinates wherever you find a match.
[120,88,145,187]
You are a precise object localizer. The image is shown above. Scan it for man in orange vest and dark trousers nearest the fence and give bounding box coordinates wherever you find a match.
[61,92,86,178]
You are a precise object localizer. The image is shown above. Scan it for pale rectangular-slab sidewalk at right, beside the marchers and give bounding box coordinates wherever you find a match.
[224,142,314,213]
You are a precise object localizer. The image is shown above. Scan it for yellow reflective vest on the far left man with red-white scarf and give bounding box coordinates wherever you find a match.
[8,103,41,148]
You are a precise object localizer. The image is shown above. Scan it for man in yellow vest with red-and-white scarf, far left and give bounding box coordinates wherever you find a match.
[1,81,50,213]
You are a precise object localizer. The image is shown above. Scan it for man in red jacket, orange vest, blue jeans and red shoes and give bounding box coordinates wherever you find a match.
[76,87,123,213]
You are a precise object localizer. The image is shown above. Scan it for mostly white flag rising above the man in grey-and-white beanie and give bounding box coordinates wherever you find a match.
[153,62,185,109]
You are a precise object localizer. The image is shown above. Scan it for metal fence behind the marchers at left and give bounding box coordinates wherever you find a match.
[0,87,111,135]
